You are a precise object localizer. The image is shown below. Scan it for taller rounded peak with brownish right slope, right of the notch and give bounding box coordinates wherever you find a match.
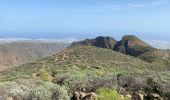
[114,35,154,57]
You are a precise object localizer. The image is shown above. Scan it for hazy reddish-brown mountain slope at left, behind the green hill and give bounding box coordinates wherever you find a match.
[0,41,69,71]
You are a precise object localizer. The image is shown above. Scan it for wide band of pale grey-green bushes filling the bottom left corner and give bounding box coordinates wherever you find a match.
[0,80,70,100]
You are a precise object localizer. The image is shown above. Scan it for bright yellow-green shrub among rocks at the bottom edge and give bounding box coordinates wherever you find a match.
[96,88,120,100]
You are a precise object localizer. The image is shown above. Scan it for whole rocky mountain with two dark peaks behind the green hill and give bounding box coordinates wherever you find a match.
[71,35,167,61]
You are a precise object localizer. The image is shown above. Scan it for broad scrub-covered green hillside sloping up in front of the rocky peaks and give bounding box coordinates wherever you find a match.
[0,46,170,100]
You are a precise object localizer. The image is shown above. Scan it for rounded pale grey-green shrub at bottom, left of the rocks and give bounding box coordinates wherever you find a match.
[30,82,69,100]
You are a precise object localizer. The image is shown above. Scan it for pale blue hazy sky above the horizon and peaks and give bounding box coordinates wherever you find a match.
[0,0,170,40]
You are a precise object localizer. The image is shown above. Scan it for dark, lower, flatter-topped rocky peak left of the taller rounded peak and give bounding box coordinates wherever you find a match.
[72,36,117,49]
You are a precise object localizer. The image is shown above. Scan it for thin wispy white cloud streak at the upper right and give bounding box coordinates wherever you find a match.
[76,0,168,12]
